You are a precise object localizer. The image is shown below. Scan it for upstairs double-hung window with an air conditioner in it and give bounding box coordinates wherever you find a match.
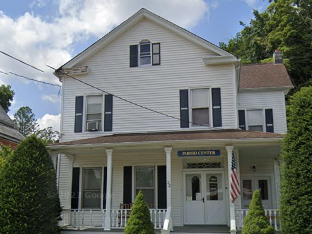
[86,95,103,131]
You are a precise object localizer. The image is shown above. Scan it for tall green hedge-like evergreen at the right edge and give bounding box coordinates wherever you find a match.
[281,87,312,234]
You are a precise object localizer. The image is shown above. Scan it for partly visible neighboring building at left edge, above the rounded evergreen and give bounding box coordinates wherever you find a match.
[0,106,25,149]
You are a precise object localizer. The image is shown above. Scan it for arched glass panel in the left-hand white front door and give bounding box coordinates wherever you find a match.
[186,174,202,201]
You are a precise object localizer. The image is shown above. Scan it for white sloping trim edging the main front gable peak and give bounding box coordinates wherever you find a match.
[57,8,235,70]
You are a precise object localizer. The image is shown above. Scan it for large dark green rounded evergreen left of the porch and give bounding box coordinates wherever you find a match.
[0,136,61,234]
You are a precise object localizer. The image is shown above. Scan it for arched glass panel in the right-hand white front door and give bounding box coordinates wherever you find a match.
[206,174,223,201]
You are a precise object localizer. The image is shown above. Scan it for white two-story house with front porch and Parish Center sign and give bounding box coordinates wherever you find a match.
[50,9,293,233]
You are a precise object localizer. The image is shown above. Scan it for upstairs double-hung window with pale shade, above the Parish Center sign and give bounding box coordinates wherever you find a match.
[191,89,210,127]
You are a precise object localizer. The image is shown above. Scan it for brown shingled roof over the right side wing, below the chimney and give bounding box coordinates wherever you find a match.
[239,63,293,90]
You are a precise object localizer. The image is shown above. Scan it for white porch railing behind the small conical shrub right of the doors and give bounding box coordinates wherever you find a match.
[236,209,281,231]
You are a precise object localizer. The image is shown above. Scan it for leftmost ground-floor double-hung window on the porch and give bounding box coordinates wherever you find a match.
[82,168,102,209]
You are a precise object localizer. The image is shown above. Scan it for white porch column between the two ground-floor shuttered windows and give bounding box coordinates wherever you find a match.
[104,149,113,230]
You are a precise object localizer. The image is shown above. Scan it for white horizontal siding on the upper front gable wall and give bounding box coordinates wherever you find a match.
[62,20,237,141]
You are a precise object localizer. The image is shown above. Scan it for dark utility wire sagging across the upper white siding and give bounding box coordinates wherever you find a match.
[47,65,207,127]
